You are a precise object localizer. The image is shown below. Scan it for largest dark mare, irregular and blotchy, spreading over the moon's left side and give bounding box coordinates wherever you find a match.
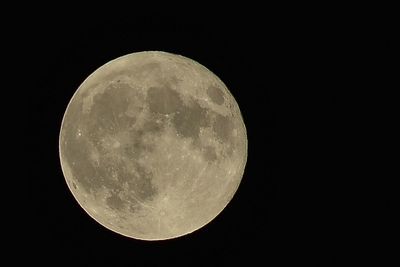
[63,84,159,209]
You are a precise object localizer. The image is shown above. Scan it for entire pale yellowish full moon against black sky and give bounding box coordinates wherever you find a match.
[59,51,247,240]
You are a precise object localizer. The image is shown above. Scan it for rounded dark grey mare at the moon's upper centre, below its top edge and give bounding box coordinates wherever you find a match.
[146,87,182,115]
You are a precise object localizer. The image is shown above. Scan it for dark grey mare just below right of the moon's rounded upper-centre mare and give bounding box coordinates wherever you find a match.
[172,101,207,138]
